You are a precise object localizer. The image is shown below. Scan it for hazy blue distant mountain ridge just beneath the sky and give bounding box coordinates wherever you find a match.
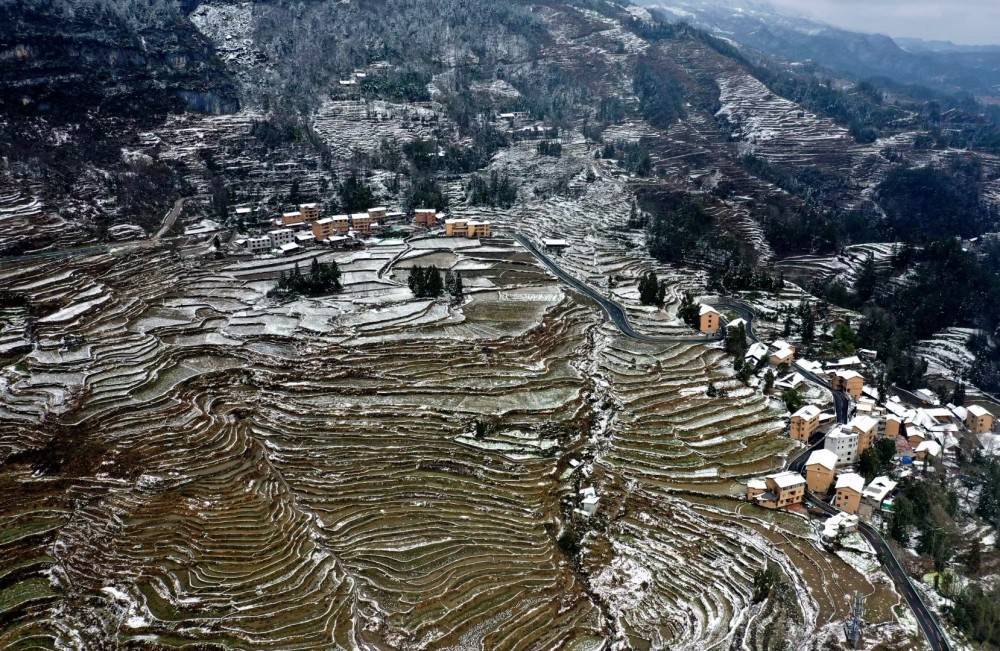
[644,0,1000,97]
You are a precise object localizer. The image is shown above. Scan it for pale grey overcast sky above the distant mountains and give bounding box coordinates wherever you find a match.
[770,0,1000,45]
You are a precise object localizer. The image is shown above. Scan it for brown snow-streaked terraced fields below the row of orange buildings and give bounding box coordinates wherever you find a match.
[0,223,908,649]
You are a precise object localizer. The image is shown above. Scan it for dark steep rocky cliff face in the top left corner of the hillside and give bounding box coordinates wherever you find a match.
[0,3,239,121]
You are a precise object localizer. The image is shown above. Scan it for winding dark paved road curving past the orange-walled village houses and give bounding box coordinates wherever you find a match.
[514,233,950,651]
